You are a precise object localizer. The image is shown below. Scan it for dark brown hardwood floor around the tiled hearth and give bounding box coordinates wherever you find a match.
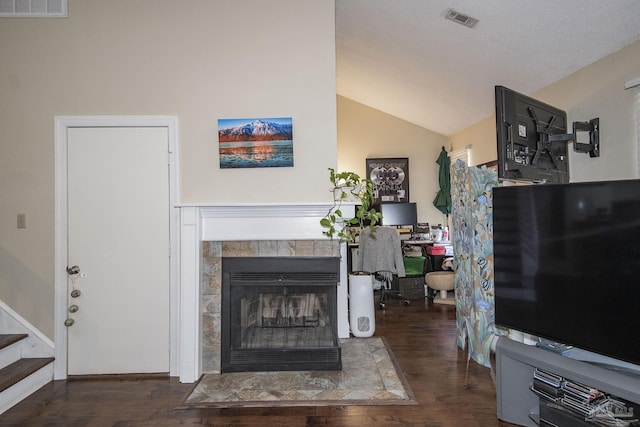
[0,300,511,427]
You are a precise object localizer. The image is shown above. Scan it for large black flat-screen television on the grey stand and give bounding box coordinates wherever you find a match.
[493,180,640,364]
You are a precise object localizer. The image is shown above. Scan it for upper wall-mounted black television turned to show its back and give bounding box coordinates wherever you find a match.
[495,86,571,183]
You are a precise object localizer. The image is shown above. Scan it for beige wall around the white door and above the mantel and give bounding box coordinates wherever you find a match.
[0,0,337,337]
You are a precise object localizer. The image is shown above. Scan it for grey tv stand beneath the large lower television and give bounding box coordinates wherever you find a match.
[496,337,640,427]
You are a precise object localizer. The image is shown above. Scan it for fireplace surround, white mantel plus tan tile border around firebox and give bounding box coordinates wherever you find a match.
[178,204,352,382]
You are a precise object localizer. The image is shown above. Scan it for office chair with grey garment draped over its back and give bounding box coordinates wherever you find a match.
[358,227,409,309]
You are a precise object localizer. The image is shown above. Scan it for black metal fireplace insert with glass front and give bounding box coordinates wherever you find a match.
[221,256,342,372]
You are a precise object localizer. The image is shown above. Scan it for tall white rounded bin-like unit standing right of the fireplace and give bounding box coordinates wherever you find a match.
[349,271,376,338]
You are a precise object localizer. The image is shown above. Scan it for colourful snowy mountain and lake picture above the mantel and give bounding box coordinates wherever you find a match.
[218,117,293,169]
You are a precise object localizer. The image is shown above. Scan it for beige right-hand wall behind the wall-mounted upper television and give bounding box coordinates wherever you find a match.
[450,42,640,182]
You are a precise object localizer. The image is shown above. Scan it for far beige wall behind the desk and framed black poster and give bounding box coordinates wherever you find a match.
[338,96,448,224]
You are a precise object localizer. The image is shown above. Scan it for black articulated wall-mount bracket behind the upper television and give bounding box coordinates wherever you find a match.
[527,107,600,167]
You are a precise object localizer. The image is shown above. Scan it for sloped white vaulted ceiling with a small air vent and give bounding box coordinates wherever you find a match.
[336,0,640,136]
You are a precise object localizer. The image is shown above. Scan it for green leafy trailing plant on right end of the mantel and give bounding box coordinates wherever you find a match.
[320,168,382,243]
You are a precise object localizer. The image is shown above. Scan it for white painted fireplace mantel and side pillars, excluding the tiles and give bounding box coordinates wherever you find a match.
[176,203,355,383]
